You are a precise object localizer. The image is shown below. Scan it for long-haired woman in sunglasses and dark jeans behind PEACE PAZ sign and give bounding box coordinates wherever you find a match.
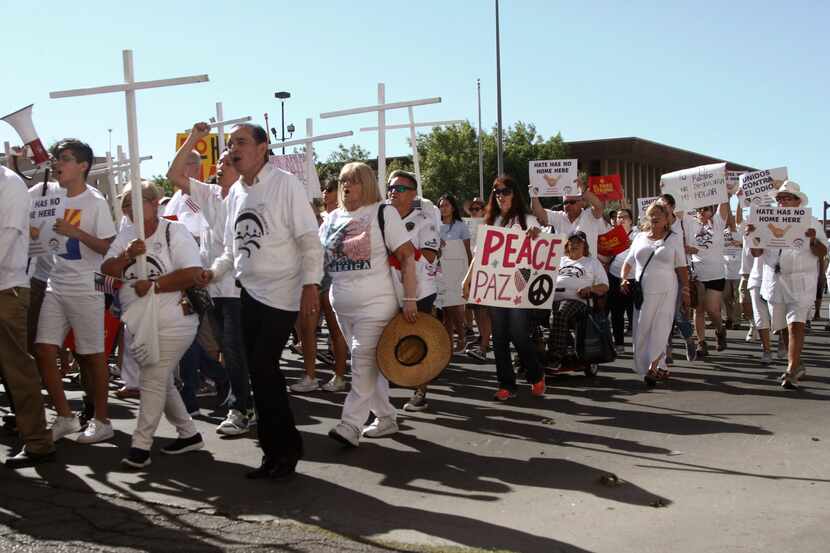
[463,175,545,401]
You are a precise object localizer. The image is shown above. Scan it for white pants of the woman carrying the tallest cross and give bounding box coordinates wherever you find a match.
[133,328,197,450]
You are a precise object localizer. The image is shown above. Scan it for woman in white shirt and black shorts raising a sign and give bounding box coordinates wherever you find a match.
[683,202,730,359]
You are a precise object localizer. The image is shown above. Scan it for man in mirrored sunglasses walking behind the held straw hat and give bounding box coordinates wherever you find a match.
[386,170,441,411]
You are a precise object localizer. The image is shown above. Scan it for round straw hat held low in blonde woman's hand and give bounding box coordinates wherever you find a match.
[376,313,452,388]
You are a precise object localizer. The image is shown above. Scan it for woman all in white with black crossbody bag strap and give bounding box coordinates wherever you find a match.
[620,203,689,387]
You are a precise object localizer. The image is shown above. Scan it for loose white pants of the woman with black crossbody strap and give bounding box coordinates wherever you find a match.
[633,286,677,376]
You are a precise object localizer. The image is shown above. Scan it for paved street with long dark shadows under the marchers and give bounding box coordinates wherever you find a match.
[0,314,830,553]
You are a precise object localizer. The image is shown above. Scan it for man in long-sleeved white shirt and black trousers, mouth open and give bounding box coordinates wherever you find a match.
[200,123,323,478]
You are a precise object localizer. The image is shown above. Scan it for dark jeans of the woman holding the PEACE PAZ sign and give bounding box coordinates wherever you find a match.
[488,307,542,391]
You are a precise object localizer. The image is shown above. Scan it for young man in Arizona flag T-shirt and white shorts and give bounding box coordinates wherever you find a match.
[35,138,116,444]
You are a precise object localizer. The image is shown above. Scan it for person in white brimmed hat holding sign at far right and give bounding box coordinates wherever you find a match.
[747,180,827,389]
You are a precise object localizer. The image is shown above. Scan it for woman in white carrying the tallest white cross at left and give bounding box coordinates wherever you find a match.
[101,182,204,468]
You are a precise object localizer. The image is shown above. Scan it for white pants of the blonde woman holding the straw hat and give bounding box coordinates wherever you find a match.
[333,295,398,429]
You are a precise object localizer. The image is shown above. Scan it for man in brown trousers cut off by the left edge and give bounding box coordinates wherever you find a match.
[0,166,55,468]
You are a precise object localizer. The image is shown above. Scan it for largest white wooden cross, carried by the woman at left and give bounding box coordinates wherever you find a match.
[49,50,208,279]
